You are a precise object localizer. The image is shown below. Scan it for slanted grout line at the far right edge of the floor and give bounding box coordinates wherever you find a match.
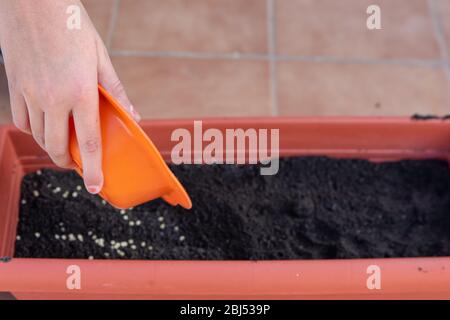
[427,0,450,114]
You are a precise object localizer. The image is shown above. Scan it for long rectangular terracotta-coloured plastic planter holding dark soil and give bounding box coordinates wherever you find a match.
[0,118,450,299]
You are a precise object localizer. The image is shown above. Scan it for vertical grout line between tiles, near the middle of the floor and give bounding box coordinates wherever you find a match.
[266,0,279,116]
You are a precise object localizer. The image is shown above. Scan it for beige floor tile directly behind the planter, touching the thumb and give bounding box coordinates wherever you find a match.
[113,57,270,118]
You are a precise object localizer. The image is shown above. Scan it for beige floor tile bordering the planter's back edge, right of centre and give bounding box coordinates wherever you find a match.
[278,62,448,116]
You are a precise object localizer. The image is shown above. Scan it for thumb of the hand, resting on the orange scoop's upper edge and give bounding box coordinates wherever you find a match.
[98,54,141,122]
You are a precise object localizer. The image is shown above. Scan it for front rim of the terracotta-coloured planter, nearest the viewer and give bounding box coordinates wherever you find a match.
[0,257,450,299]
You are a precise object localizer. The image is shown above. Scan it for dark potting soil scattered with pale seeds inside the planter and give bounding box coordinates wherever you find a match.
[15,157,450,260]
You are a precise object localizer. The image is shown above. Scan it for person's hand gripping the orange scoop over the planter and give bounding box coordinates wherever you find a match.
[0,0,140,194]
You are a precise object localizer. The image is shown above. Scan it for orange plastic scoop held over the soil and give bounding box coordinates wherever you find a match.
[69,86,192,209]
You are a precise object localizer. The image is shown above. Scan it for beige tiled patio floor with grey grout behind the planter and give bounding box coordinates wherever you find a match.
[0,0,450,122]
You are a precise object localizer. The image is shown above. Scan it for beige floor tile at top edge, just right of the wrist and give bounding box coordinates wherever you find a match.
[113,0,267,53]
